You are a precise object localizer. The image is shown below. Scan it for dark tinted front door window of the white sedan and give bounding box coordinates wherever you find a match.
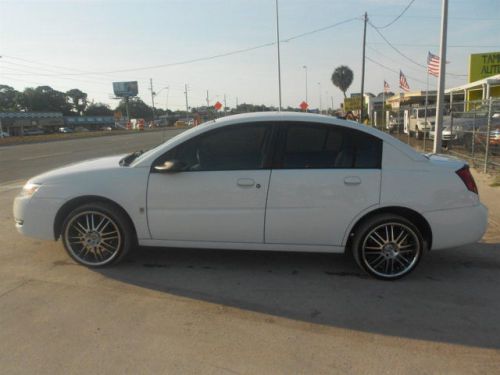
[160,125,270,171]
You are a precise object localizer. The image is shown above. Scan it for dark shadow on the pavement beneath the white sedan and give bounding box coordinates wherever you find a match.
[94,243,500,349]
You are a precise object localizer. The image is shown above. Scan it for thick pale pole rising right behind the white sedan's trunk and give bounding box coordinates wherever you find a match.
[433,0,448,154]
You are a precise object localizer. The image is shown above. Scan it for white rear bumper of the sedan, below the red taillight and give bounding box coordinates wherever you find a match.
[424,204,488,250]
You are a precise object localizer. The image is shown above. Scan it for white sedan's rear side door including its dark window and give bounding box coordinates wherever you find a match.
[265,123,382,246]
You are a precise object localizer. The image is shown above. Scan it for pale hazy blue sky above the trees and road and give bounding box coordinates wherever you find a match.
[0,0,500,110]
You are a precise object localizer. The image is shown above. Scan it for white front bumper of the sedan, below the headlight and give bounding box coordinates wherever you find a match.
[14,196,62,240]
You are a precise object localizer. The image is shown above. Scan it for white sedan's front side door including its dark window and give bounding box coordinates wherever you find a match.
[147,123,272,243]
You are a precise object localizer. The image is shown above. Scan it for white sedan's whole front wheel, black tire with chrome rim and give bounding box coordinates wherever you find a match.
[61,202,136,268]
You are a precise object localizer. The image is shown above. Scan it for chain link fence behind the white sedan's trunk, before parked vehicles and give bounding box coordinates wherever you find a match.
[372,99,500,175]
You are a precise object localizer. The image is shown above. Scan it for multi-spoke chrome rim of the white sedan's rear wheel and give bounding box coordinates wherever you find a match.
[362,223,421,278]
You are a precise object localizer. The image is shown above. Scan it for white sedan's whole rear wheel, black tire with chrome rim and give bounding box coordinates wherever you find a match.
[351,214,425,280]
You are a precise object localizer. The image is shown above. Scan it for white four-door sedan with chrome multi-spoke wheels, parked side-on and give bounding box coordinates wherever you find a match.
[14,112,487,280]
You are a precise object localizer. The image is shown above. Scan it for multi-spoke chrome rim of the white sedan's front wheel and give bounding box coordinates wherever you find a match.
[64,211,122,266]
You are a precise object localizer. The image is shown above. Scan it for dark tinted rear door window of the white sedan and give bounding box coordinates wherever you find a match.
[282,124,382,169]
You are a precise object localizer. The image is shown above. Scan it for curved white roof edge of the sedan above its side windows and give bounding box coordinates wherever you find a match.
[136,112,427,166]
